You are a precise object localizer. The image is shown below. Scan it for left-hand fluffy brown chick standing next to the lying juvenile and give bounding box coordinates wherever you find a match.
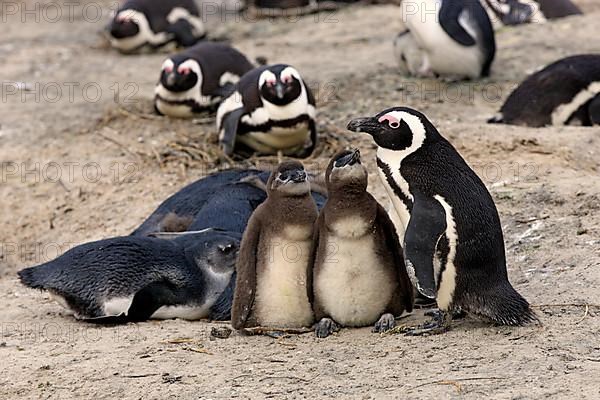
[231,161,317,330]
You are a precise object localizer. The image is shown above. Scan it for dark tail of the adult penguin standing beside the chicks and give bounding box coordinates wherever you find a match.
[469,282,540,326]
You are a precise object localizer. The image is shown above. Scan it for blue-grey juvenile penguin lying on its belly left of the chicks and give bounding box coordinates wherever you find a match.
[19,231,239,323]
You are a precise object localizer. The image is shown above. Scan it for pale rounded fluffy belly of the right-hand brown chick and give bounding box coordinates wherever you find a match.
[314,218,396,326]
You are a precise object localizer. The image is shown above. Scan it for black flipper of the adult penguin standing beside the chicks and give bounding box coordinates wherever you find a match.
[404,191,446,298]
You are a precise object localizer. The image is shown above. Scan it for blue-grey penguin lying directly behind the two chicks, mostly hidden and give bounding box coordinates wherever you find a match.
[132,169,326,236]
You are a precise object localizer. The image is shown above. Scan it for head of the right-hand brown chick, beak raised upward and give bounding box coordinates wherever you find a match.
[325,149,368,193]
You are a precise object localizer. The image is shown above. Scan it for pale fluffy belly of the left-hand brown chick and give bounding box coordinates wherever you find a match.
[255,225,313,328]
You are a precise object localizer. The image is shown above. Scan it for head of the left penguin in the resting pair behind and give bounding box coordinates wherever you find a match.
[160,56,202,93]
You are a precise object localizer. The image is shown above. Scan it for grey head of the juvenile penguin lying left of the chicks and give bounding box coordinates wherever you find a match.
[190,231,240,274]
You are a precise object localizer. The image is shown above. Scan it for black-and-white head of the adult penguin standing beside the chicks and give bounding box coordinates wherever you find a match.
[347,107,441,154]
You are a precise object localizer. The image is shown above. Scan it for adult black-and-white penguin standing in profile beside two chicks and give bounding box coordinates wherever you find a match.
[348,107,536,334]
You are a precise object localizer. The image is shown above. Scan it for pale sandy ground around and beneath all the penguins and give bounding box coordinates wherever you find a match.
[0,0,600,400]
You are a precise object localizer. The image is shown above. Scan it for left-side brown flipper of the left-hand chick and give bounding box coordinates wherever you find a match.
[231,212,261,330]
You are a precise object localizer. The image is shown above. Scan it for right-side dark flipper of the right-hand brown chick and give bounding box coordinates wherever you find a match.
[377,204,414,312]
